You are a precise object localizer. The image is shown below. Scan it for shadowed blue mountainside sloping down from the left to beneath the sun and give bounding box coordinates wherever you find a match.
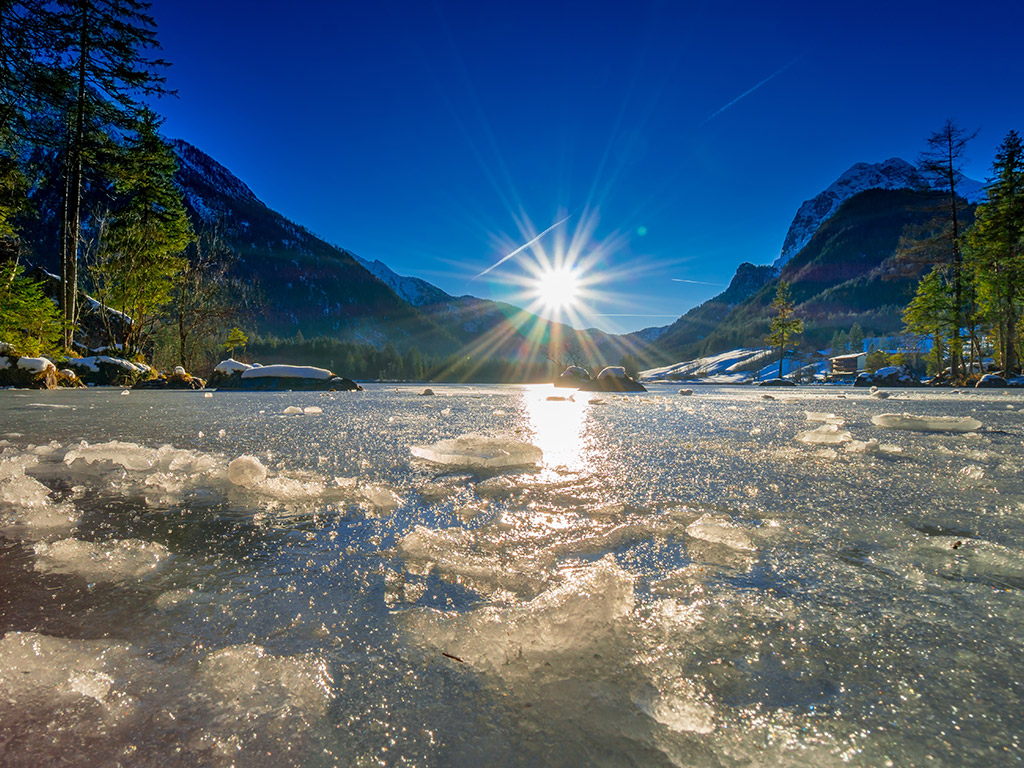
[172,140,637,366]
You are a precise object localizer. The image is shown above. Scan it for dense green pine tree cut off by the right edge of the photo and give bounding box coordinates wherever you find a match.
[968,131,1024,375]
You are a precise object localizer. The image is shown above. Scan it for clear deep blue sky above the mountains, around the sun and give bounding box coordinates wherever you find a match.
[152,0,1024,332]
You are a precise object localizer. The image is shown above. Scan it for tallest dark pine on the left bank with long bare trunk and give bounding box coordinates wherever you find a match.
[55,0,170,345]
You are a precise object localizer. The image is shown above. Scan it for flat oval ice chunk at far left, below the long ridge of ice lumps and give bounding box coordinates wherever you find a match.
[35,539,170,582]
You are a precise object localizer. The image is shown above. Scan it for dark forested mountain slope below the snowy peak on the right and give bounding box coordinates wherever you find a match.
[655,189,962,360]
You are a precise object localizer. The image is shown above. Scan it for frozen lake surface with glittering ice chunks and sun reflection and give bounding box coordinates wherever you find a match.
[0,385,1024,768]
